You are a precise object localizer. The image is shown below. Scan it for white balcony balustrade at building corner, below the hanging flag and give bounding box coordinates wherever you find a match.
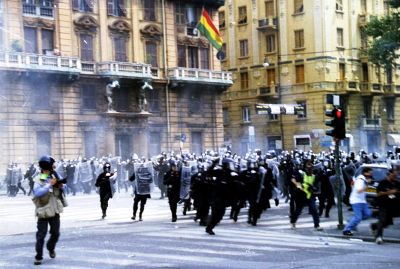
[168,67,233,85]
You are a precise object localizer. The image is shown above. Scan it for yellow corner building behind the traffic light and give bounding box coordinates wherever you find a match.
[219,0,400,153]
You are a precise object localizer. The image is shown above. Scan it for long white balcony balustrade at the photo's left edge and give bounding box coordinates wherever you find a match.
[0,52,80,72]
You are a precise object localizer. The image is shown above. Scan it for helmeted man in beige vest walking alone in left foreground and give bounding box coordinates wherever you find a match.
[32,156,66,265]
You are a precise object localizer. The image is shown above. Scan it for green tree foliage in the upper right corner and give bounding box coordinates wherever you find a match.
[363,0,400,70]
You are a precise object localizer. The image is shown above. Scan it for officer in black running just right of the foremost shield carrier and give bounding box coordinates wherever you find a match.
[164,161,181,222]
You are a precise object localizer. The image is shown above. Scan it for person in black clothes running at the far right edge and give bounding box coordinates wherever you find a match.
[371,169,400,244]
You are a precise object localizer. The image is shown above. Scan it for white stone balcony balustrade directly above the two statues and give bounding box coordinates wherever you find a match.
[96,62,153,78]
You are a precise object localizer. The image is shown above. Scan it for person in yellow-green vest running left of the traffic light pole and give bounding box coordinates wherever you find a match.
[290,161,322,231]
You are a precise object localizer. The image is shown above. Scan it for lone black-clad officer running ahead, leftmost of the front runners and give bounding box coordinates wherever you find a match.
[95,163,116,219]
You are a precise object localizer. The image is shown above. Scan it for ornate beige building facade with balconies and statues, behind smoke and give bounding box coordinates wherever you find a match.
[0,0,232,167]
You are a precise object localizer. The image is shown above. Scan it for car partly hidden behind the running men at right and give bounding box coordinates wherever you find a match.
[353,163,391,208]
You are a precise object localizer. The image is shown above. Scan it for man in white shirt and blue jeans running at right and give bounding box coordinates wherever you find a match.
[343,167,372,236]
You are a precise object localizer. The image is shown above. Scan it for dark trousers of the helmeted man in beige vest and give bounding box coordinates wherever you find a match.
[35,214,60,260]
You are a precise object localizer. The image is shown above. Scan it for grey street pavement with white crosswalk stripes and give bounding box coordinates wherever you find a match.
[0,188,400,269]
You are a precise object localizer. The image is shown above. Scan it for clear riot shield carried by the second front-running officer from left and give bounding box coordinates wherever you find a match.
[134,162,154,195]
